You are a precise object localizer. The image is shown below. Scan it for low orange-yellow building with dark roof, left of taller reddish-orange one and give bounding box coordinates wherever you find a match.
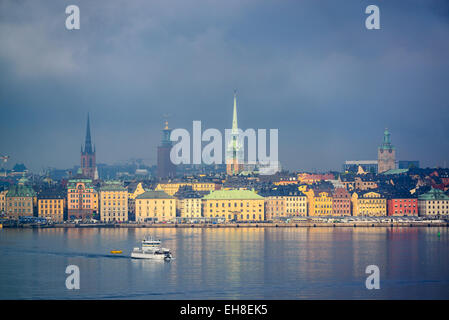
[37,189,66,222]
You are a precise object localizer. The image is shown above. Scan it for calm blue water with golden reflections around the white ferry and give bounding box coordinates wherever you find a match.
[0,228,449,299]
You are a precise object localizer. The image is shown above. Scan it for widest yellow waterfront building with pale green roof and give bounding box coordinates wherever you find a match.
[203,189,265,221]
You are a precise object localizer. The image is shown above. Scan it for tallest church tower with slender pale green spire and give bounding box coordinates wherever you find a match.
[226,92,244,175]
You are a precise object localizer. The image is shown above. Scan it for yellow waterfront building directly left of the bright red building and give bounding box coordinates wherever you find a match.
[351,191,387,217]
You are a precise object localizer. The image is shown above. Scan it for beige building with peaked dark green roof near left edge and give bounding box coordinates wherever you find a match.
[5,177,37,219]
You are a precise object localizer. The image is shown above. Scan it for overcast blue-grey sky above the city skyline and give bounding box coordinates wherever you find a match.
[0,0,449,170]
